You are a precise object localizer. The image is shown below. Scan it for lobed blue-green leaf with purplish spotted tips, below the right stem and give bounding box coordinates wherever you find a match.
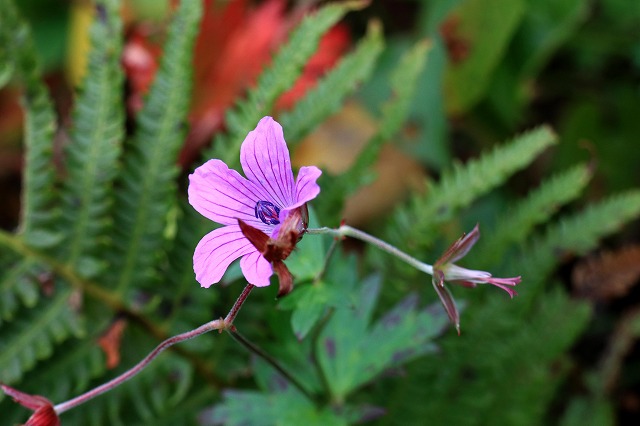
[317,277,448,403]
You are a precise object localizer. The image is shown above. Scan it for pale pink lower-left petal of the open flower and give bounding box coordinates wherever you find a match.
[193,225,259,288]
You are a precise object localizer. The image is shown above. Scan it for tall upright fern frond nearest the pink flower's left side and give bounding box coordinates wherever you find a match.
[109,1,202,291]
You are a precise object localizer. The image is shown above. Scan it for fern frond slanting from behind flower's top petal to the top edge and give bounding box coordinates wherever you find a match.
[212,1,365,168]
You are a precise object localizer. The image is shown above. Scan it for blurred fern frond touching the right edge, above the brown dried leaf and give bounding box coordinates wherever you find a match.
[513,190,640,302]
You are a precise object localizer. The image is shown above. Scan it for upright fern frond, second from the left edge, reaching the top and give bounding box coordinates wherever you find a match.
[63,0,124,276]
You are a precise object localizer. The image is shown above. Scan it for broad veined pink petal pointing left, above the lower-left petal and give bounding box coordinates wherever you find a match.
[189,160,270,231]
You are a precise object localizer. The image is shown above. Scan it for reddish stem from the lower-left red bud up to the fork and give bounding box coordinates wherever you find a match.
[53,320,225,414]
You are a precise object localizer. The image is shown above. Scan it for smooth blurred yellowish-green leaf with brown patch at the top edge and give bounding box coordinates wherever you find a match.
[444,0,527,114]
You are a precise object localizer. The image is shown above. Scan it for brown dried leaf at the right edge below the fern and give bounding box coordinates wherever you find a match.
[572,245,640,301]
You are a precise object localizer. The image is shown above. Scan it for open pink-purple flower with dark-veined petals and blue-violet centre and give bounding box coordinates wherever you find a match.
[189,117,322,287]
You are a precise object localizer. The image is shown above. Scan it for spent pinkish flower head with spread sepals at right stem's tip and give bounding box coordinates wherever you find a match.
[432,225,522,334]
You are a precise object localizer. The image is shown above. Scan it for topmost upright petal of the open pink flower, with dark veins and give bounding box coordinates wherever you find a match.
[240,117,295,208]
